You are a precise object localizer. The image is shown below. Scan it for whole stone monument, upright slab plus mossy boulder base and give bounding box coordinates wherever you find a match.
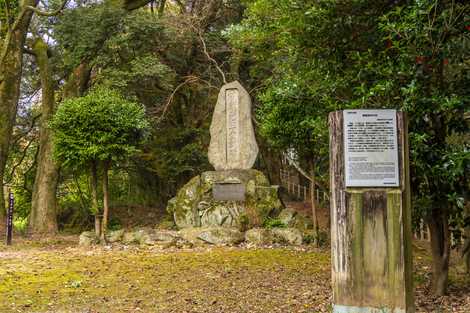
[167,81,281,228]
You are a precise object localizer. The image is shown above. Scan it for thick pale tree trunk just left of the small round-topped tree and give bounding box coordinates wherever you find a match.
[29,38,59,234]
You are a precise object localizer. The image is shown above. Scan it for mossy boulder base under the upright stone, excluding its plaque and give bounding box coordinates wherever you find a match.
[167,169,282,228]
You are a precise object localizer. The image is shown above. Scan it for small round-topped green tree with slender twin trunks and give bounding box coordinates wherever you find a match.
[50,88,149,240]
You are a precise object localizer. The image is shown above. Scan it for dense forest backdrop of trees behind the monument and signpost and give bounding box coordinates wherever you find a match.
[0,0,470,294]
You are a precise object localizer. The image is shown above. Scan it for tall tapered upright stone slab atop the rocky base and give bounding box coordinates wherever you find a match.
[209,81,258,171]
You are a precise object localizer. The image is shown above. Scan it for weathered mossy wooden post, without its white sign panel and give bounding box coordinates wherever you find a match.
[329,110,414,313]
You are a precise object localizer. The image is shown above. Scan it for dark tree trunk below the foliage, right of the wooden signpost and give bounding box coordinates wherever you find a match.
[428,210,450,296]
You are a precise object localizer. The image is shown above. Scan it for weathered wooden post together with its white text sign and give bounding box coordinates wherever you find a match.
[329,110,414,313]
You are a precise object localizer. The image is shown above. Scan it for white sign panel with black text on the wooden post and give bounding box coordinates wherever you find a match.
[343,110,400,187]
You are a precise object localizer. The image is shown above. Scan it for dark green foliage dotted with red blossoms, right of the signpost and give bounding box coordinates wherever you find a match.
[380,1,470,230]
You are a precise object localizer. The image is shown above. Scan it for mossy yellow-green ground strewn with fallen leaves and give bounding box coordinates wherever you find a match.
[0,237,470,313]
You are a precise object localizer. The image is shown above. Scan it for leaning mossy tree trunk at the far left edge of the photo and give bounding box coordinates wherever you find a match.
[0,0,38,229]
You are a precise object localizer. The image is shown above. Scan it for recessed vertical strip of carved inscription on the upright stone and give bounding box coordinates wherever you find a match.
[225,89,240,164]
